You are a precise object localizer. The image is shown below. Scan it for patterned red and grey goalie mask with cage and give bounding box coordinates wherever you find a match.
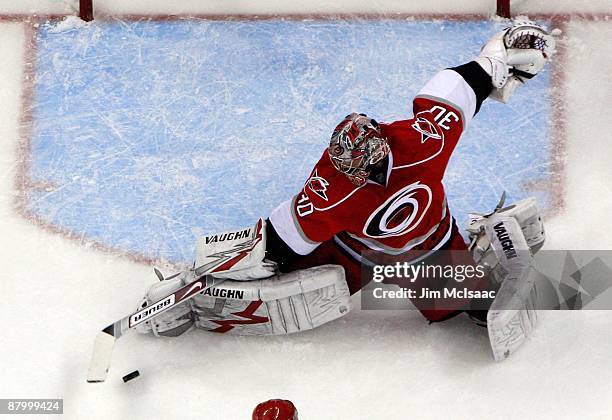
[327,113,389,186]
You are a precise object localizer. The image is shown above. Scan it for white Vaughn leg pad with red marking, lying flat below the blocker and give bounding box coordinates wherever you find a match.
[192,265,351,335]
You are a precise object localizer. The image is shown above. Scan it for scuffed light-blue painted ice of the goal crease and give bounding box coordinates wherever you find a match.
[28,20,549,263]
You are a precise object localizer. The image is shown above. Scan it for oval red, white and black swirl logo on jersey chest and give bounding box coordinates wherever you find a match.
[363,181,432,238]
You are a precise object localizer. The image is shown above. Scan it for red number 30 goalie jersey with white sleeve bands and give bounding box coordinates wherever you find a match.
[270,69,482,261]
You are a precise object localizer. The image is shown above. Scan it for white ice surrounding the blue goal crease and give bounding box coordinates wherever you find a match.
[0,8,612,420]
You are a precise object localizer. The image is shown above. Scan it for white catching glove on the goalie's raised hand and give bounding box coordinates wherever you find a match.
[475,20,561,102]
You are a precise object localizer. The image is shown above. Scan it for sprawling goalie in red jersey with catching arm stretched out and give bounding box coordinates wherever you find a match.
[138,21,556,360]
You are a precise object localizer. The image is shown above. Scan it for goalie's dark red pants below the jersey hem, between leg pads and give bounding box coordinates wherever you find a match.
[283,221,489,322]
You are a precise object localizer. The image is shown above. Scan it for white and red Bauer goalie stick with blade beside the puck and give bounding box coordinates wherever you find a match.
[87,220,263,383]
